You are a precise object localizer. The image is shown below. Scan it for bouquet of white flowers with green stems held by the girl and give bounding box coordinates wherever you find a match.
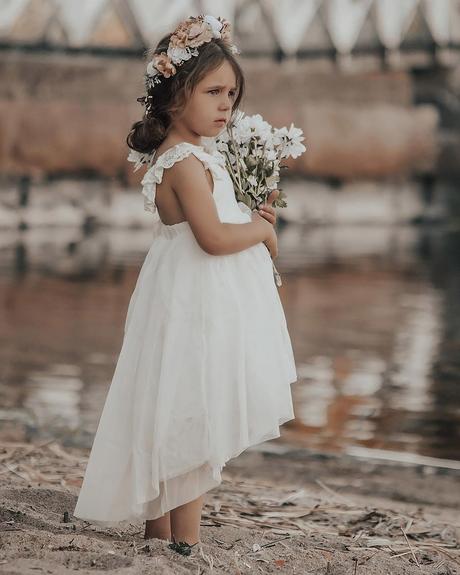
[211,111,306,286]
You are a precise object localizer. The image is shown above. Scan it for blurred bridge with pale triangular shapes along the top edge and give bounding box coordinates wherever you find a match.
[0,0,460,67]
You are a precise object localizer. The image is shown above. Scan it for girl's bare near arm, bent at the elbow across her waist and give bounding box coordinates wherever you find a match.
[170,154,275,255]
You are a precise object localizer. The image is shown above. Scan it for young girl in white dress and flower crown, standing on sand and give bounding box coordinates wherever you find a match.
[74,15,297,554]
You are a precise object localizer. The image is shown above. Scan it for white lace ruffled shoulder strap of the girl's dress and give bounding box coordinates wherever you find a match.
[141,142,225,219]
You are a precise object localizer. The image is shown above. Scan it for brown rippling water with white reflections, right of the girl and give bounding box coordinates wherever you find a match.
[283,224,460,459]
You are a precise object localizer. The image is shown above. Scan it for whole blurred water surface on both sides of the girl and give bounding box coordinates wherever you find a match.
[0,222,460,459]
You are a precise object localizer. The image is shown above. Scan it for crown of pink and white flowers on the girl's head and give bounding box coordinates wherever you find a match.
[137,14,240,112]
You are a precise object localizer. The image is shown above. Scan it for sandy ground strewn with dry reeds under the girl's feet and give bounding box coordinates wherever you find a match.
[0,441,460,575]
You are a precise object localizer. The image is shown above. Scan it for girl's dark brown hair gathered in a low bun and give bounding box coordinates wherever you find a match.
[126,33,245,153]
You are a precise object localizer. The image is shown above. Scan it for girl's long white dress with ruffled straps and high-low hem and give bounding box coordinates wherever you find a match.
[73,142,297,526]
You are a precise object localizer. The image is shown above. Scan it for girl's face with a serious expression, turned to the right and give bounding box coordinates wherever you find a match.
[175,60,237,137]
